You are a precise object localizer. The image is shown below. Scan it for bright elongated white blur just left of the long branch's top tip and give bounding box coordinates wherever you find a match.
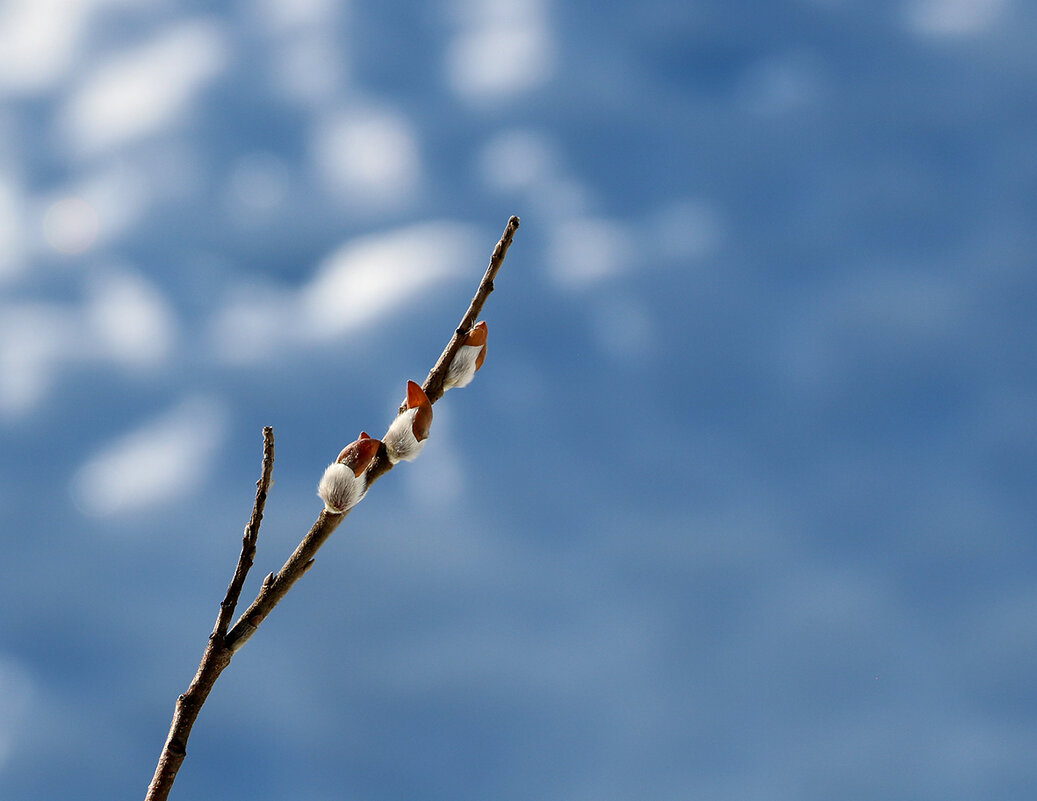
[299,221,482,338]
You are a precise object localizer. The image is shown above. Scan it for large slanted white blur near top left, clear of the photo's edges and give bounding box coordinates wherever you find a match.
[63,21,227,154]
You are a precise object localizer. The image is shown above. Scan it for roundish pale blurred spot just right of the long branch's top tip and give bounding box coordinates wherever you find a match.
[546,217,635,289]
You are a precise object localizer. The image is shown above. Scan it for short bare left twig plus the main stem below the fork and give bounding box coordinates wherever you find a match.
[145,425,274,801]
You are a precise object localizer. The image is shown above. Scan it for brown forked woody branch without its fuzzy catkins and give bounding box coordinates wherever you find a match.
[145,217,519,801]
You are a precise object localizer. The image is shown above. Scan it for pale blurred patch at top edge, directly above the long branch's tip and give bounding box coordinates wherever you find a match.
[446,0,555,102]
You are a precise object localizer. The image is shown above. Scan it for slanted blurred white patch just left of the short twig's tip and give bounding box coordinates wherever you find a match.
[72,396,227,517]
